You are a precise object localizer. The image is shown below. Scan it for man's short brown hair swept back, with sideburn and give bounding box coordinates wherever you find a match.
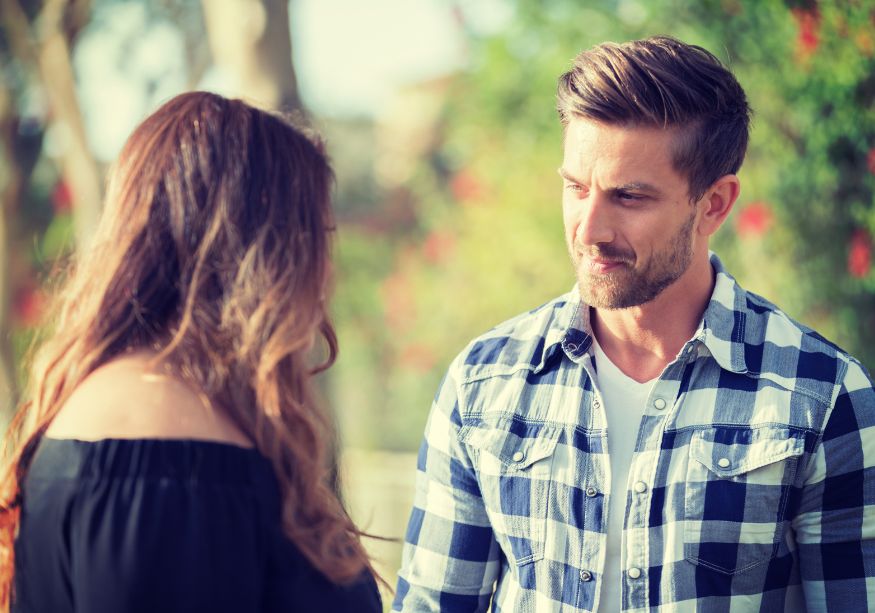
[557,36,751,201]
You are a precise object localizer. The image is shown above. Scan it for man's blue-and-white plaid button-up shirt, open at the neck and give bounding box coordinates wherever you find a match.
[393,256,875,613]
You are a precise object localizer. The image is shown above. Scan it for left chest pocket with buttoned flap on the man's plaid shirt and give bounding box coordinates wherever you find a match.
[459,418,561,565]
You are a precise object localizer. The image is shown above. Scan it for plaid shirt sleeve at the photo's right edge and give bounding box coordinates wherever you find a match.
[793,361,875,611]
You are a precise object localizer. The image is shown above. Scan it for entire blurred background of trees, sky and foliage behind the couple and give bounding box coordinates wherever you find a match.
[0,0,875,607]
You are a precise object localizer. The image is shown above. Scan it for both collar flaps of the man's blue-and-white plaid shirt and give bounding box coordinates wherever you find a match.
[535,252,755,373]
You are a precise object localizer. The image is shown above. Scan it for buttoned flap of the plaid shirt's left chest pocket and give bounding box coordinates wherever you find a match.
[459,417,562,470]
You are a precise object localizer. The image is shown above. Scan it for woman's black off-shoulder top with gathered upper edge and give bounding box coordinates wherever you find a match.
[12,438,382,613]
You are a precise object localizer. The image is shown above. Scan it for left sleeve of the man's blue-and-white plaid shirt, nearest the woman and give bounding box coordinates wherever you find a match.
[392,358,500,613]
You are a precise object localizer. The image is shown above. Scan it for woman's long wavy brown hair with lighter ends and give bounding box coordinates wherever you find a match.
[0,92,370,603]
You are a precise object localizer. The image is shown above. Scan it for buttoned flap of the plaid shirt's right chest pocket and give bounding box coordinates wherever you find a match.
[690,426,805,478]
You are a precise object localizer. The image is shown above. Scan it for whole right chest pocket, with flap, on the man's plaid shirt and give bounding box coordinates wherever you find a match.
[684,426,804,574]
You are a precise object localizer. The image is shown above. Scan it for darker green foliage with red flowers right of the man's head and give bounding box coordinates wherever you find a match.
[697,1,875,356]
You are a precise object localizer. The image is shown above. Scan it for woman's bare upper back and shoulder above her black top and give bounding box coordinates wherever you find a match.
[46,353,252,447]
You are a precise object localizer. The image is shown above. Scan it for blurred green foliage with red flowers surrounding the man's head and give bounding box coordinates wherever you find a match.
[338,0,875,449]
